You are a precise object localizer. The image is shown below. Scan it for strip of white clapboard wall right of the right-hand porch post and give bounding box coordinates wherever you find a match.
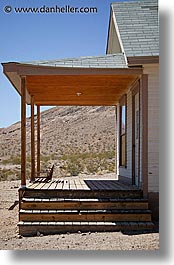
[144,64,160,192]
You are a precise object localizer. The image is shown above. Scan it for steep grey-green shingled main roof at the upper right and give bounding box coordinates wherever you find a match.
[111,0,159,57]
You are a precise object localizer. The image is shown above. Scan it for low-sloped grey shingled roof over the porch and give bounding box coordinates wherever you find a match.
[21,53,127,68]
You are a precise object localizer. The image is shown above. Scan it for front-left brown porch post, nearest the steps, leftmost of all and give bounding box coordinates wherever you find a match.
[21,77,26,187]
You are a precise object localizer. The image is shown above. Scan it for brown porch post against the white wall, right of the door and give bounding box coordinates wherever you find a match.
[140,74,148,198]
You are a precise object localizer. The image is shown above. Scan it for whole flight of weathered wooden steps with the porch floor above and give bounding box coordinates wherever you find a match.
[19,179,152,235]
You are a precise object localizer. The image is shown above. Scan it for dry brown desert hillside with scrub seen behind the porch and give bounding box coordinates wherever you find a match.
[0,107,116,180]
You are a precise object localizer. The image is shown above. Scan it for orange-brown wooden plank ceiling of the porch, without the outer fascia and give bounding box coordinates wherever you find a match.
[26,75,139,105]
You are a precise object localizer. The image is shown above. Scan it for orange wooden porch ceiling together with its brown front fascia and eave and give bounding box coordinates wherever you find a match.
[3,63,142,106]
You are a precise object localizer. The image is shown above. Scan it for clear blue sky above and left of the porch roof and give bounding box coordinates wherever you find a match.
[0,0,161,127]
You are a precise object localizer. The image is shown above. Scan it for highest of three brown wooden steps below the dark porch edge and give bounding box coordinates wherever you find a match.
[21,198,148,210]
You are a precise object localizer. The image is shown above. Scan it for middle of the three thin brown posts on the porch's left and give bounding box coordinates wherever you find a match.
[30,97,35,182]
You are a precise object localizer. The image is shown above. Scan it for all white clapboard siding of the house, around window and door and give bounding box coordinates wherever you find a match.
[117,64,159,192]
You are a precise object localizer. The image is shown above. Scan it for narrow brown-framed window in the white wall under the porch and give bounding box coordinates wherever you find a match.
[120,96,127,167]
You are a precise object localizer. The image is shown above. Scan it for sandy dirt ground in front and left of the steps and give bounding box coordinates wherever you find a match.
[0,177,159,250]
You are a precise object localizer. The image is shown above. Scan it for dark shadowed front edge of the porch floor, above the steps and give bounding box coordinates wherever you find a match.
[23,188,143,199]
